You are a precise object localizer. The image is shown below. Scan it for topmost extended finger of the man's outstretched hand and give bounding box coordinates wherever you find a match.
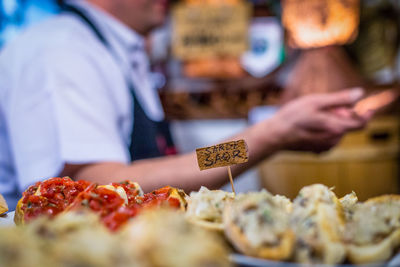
[310,87,364,109]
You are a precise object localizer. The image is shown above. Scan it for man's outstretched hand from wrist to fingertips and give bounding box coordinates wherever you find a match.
[271,88,371,153]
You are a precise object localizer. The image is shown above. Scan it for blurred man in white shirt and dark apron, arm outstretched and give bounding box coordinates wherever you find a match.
[0,0,367,209]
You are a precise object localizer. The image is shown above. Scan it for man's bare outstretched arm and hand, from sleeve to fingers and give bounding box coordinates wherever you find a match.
[62,89,372,194]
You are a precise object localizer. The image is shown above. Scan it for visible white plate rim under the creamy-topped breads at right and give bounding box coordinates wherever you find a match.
[230,253,400,267]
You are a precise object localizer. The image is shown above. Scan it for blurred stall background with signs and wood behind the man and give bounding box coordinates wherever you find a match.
[0,0,400,198]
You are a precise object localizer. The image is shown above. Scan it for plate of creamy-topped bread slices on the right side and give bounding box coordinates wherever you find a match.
[187,184,400,267]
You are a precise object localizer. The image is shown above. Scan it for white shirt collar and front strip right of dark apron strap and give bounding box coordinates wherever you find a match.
[67,0,164,121]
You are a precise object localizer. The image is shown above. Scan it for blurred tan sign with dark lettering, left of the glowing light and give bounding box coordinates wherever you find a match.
[172,1,250,59]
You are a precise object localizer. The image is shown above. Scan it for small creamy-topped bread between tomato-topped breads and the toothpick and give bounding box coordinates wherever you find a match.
[186,186,234,231]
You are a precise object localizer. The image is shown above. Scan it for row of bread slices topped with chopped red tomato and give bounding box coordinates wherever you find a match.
[15,177,186,231]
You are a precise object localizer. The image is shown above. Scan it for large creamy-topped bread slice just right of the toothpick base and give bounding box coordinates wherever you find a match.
[223,190,295,260]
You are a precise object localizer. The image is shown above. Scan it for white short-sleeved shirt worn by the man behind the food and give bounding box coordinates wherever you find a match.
[0,1,163,208]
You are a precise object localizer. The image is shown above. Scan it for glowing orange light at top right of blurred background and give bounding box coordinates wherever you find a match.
[282,0,360,48]
